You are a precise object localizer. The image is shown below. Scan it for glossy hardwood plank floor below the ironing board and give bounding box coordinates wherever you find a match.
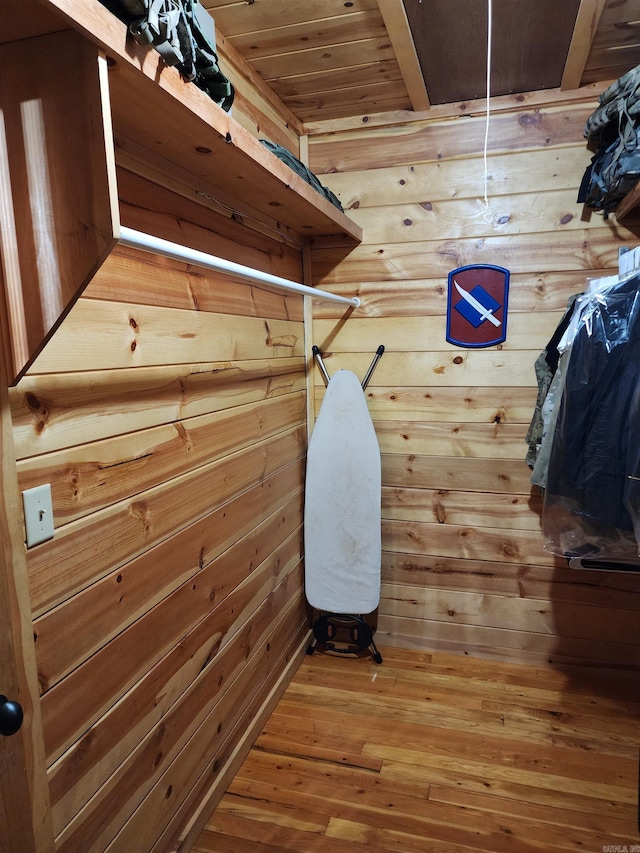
[193,648,640,853]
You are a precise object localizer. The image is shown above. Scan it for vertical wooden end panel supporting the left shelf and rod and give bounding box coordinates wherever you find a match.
[0,27,119,382]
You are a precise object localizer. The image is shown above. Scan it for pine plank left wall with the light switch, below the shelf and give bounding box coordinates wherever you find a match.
[11,172,308,853]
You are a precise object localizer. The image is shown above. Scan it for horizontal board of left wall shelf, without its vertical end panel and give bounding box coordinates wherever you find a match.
[31,0,362,245]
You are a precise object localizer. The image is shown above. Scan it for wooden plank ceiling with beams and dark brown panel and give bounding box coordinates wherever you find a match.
[201,0,640,122]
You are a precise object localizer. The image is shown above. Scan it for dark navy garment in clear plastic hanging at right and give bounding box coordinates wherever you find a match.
[543,276,640,557]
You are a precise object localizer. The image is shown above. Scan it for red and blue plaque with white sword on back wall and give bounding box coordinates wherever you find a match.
[447,264,509,347]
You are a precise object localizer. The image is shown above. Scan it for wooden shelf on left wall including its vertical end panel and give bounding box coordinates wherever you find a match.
[0,0,362,382]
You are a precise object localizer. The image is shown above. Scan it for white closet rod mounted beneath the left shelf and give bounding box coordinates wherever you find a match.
[119,227,360,308]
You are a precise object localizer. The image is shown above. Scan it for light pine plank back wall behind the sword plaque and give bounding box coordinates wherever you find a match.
[310,92,640,668]
